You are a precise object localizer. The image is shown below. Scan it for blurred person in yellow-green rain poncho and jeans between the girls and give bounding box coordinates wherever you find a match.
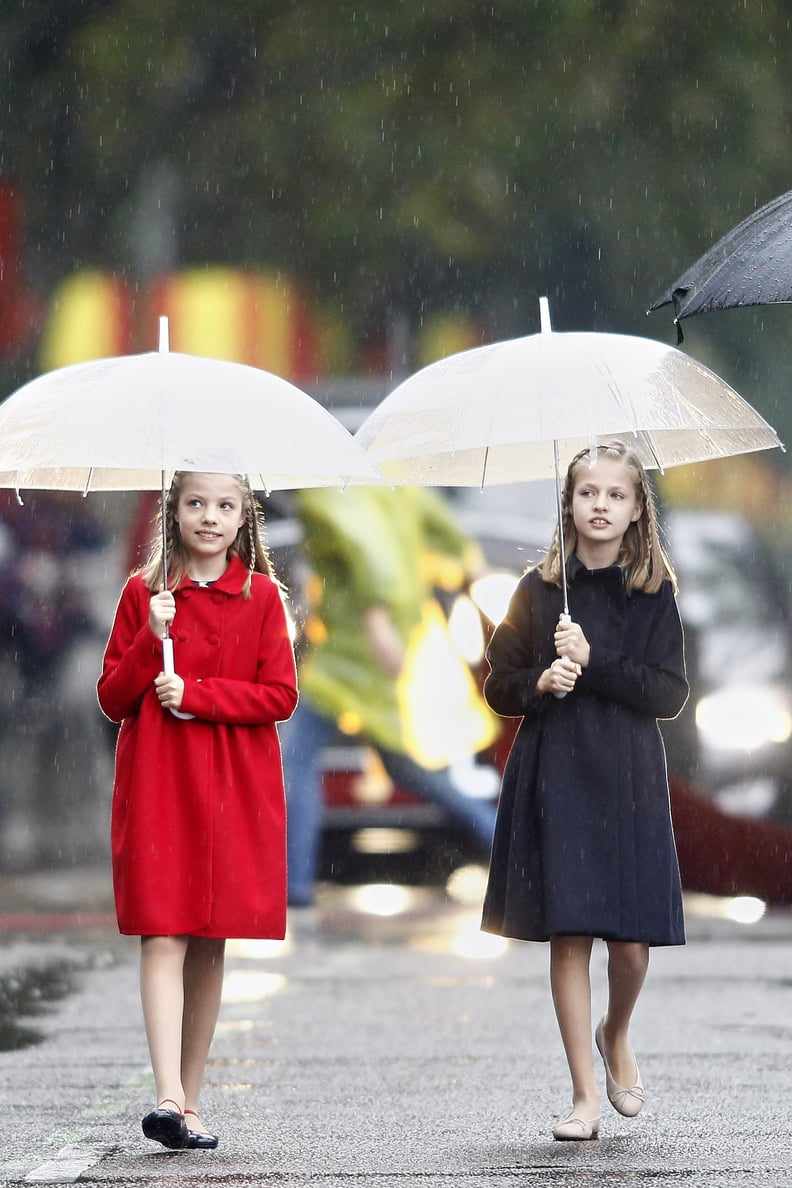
[280,487,499,906]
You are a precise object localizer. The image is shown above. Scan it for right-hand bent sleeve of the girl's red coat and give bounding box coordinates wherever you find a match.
[182,581,297,726]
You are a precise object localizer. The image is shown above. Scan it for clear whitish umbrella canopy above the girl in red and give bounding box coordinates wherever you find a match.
[0,320,384,493]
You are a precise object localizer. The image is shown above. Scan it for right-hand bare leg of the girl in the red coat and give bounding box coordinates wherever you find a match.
[182,936,226,1131]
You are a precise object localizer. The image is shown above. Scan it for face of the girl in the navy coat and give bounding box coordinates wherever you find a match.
[572,457,644,563]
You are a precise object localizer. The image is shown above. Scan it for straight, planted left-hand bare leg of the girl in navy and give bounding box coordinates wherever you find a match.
[550,936,600,1120]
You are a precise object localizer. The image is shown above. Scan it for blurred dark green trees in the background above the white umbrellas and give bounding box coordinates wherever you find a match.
[0,0,792,449]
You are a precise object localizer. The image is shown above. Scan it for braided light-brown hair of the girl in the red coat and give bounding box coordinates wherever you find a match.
[139,470,278,598]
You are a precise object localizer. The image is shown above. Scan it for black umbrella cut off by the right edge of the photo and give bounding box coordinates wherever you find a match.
[647,190,792,342]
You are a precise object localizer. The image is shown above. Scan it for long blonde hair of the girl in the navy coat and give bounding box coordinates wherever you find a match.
[538,441,677,594]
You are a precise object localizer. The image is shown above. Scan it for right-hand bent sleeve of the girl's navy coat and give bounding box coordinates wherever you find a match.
[581,581,689,719]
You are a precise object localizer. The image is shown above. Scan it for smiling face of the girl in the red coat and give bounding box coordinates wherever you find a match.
[176,474,245,576]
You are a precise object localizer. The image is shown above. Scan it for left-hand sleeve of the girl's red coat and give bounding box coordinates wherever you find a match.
[96,579,163,722]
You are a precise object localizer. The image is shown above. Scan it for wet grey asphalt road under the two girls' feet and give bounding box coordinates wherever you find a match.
[0,869,792,1188]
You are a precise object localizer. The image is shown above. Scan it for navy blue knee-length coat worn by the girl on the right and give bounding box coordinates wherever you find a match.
[482,557,688,944]
